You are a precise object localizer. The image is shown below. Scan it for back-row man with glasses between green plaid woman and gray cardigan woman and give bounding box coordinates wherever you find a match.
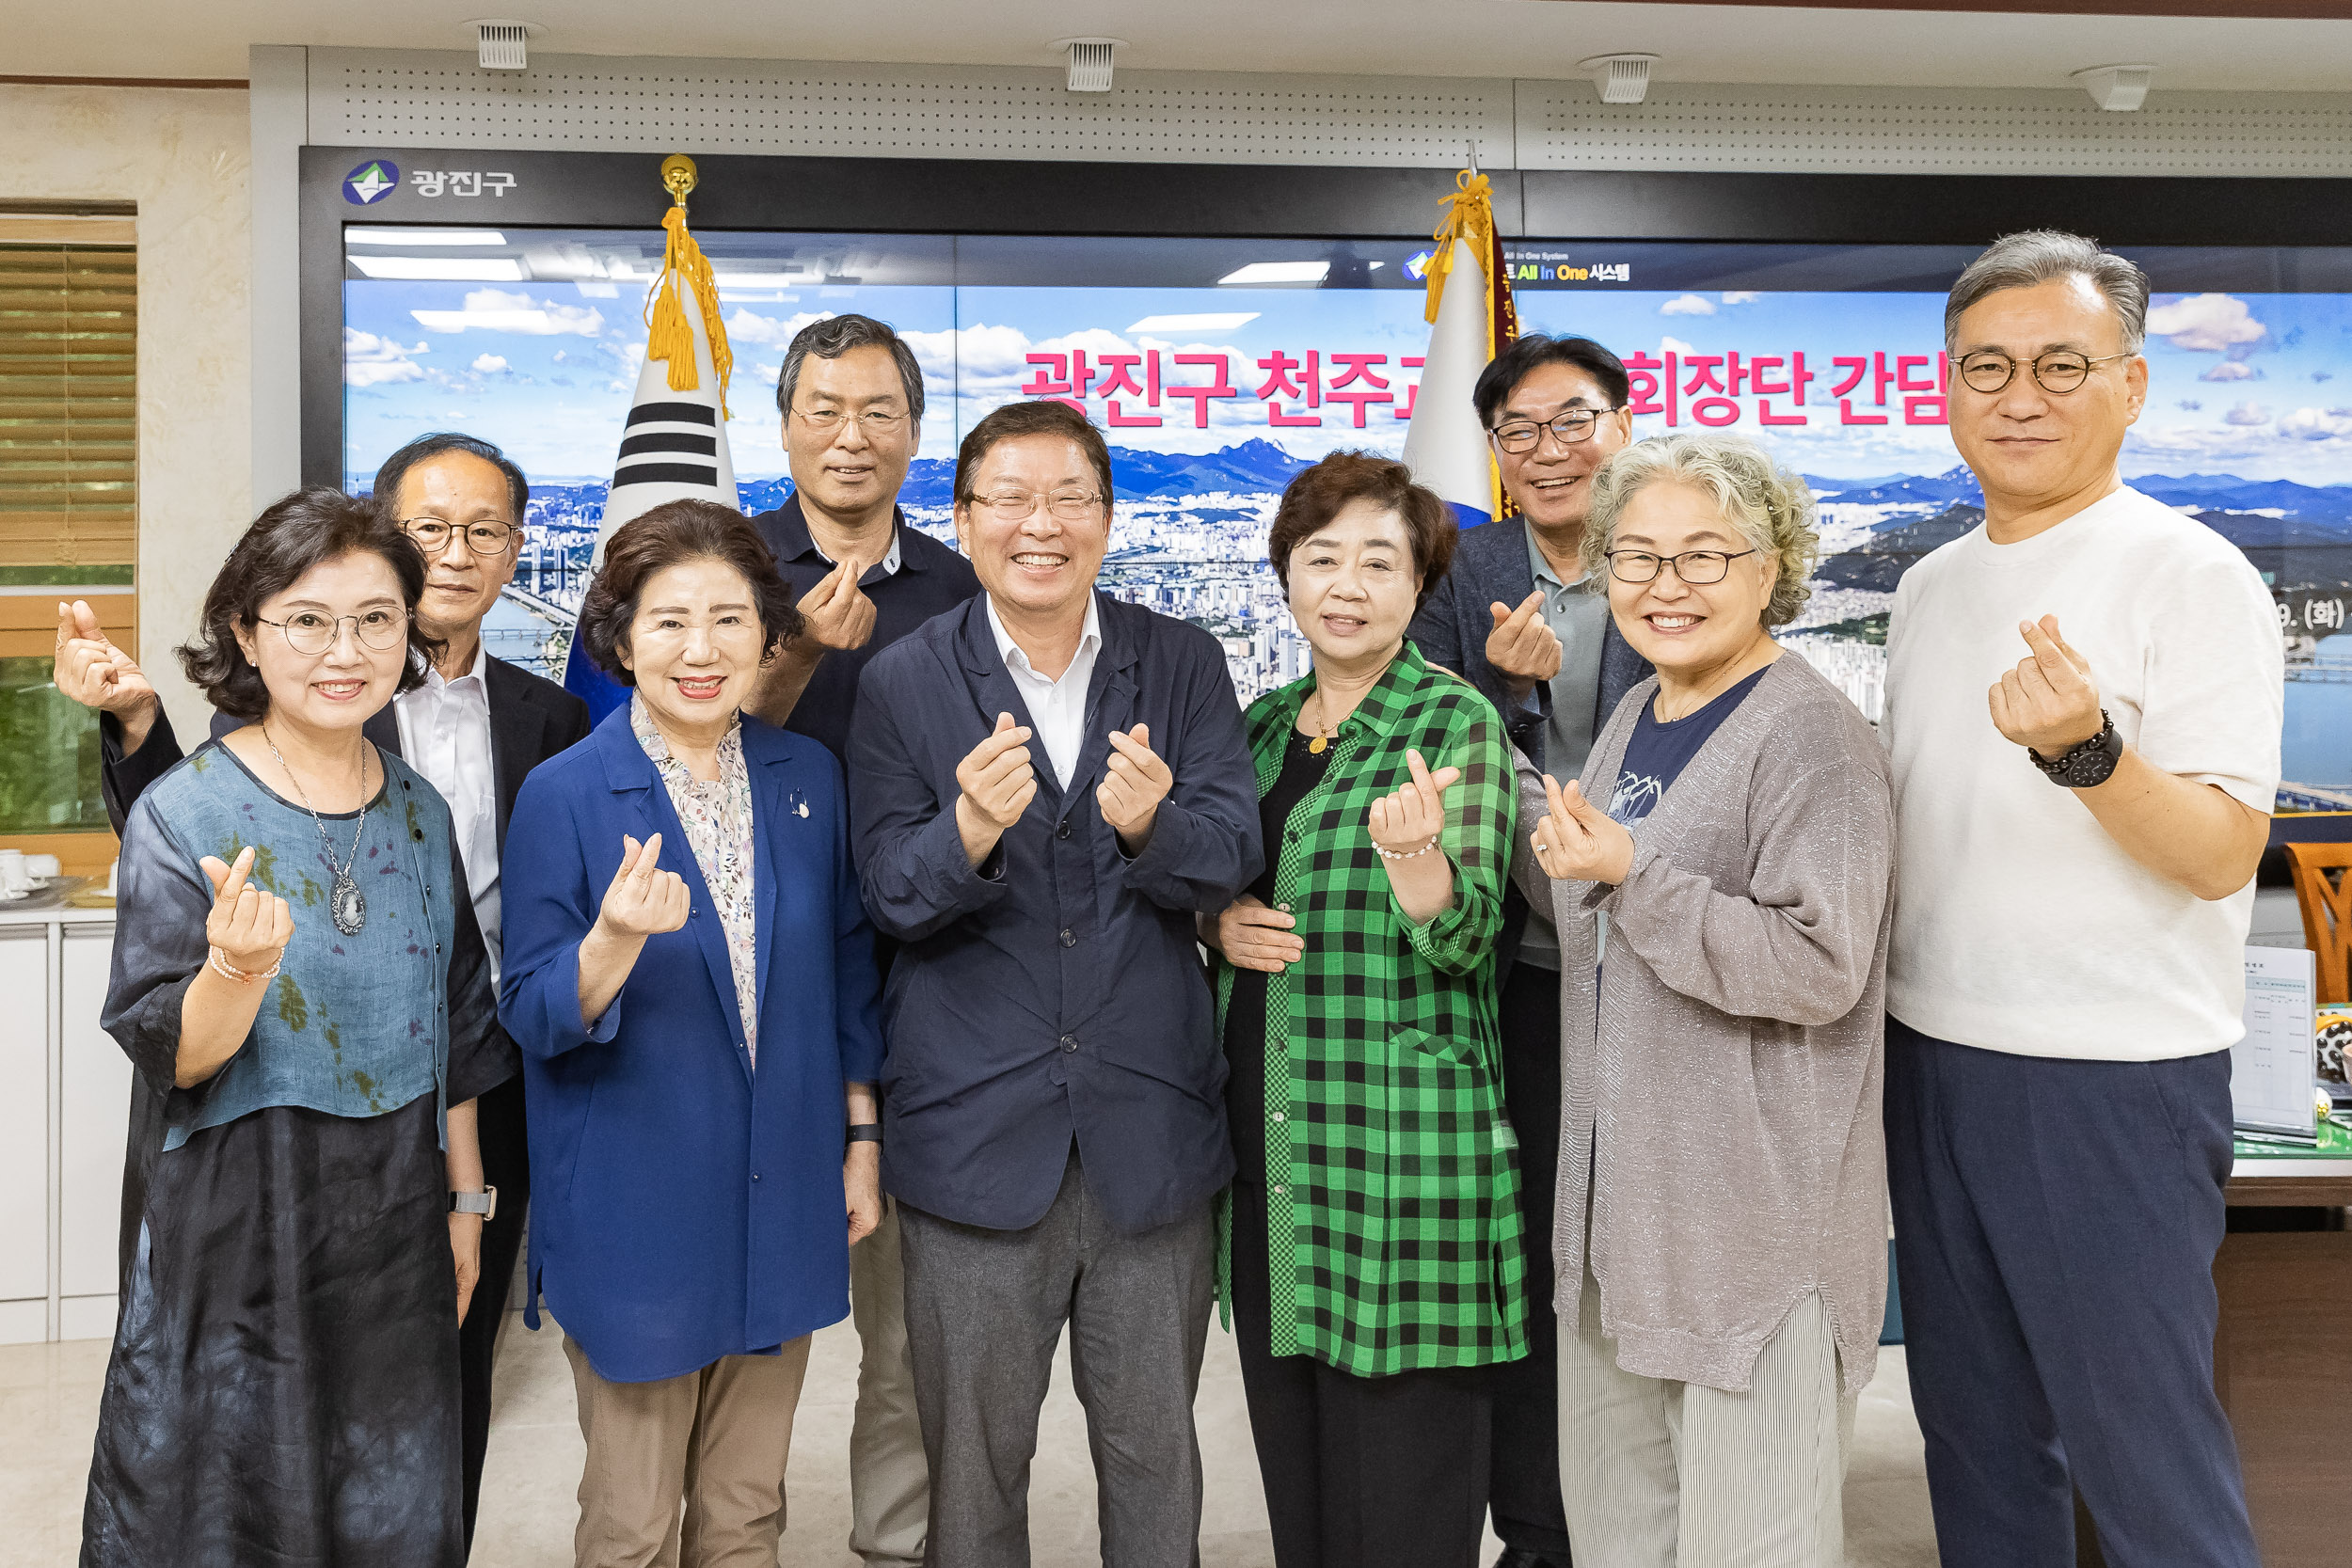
[1409,334,1649,1568]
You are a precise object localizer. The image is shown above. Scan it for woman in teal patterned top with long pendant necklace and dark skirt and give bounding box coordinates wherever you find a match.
[83,489,516,1568]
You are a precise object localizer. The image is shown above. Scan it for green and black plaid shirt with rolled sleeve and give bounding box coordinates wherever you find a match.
[1216,641,1527,1378]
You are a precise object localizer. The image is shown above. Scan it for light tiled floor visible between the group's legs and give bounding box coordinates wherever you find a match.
[0,1319,1936,1568]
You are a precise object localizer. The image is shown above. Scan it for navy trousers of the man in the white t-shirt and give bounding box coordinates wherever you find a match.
[1886,1018,2261,1568]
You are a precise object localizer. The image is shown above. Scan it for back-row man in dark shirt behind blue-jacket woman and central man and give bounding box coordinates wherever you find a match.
[753,315,981,1568]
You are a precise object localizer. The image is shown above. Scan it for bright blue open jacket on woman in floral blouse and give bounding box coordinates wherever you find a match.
[499,705,882,1383]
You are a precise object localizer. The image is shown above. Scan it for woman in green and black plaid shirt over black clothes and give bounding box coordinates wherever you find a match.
[1202,451,1527,1568]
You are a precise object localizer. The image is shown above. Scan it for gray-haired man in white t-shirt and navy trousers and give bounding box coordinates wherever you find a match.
[1884,232,2281,1568]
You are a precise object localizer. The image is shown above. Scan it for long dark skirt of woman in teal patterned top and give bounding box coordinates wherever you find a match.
[83,1093,466,1568]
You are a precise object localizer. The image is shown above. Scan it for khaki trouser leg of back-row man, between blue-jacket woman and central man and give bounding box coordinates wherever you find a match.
[850,1199,931,1568]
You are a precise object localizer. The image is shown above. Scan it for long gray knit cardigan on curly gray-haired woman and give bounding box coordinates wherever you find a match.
[1513,654,1894,1394]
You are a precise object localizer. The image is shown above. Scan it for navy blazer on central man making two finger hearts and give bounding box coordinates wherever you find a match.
[850,594,1261,1234]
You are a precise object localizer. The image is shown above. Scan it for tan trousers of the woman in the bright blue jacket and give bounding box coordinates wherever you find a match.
[564,1336,809,1568]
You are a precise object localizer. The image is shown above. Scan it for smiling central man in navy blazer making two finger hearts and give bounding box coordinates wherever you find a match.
[850,402,1261,1568]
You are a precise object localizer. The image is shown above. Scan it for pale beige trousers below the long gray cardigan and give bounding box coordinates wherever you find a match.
[1560,1270,1856,1568]
